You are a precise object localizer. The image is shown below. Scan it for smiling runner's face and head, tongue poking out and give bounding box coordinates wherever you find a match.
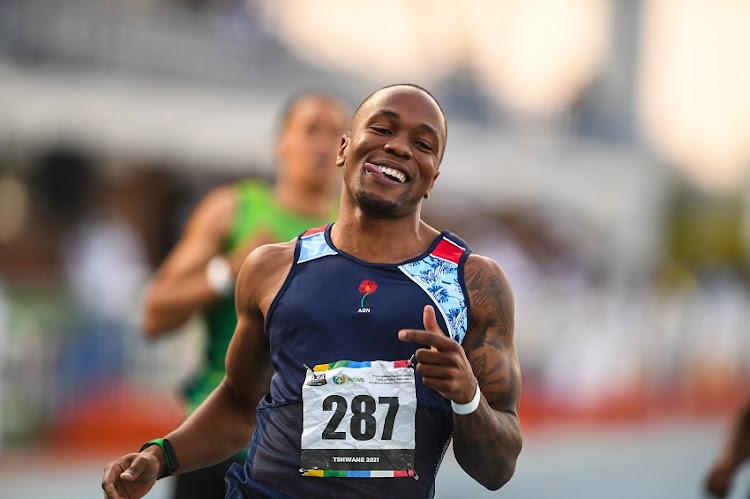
[336,86,446,218]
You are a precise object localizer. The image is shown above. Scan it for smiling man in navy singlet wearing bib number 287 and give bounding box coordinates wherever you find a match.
[102,84,521,498]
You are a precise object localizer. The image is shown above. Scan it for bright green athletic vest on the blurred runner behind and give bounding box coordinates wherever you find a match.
[185,180,335,412]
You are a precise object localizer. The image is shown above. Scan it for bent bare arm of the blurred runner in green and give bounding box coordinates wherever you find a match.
[142,186,235,337]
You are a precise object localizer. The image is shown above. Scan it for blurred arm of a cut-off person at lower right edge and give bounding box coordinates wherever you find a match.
[706,398,750,497]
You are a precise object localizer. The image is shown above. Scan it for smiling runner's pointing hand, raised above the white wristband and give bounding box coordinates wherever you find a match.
[398,305,477,404]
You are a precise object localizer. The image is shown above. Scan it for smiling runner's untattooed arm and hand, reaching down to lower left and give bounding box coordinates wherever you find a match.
[102,244,294,499]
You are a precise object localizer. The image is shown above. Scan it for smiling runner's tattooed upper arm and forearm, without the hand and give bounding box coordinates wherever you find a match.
[453,255,521,489]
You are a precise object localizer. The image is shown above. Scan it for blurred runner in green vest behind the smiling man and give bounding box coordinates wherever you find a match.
[143,92,349,499]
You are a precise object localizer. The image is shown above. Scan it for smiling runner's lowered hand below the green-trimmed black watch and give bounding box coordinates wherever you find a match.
[102,452,159,499]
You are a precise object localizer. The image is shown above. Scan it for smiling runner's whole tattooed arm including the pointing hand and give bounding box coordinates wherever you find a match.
[399,255,521,490]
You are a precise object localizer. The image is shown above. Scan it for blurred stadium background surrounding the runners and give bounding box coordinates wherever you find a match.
[0,0,750,499]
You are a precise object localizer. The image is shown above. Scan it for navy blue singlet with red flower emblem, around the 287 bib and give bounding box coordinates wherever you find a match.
[226,225,470,499]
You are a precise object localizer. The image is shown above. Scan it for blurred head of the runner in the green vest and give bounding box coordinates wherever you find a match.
[278,96,348,190]
